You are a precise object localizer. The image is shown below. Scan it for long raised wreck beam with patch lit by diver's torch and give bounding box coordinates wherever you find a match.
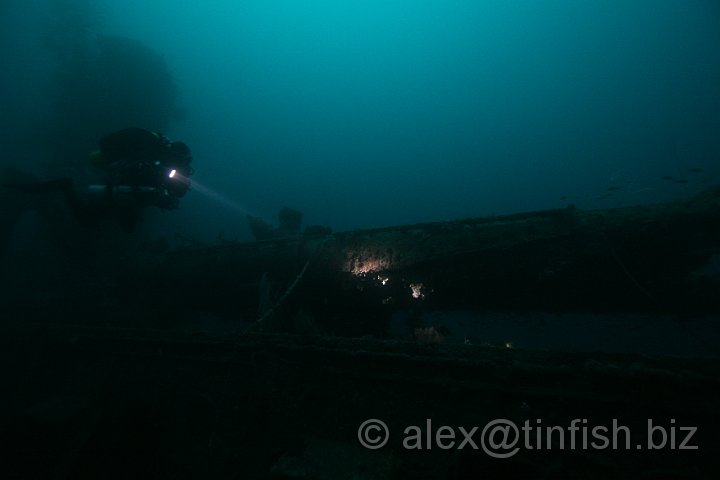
[148,188,720,342]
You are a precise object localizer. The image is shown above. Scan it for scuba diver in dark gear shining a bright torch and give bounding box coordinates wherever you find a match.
[4,128,193,232]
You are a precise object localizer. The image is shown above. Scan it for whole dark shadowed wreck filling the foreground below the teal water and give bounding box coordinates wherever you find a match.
[0,189,720,479]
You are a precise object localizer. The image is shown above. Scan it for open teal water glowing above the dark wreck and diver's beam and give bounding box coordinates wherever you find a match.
[0,0,720,238]
